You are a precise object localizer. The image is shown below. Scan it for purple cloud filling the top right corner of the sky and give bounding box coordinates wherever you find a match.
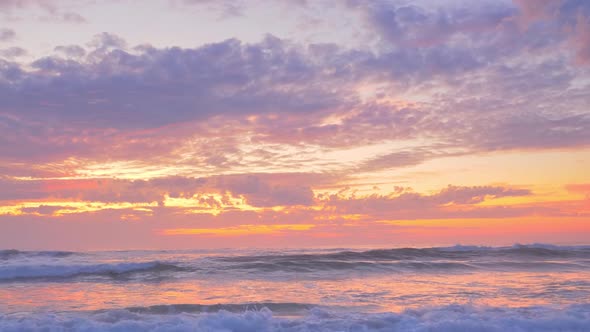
[348,0,590,67]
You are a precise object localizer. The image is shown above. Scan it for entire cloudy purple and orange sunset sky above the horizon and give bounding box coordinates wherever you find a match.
[0,0,590,250]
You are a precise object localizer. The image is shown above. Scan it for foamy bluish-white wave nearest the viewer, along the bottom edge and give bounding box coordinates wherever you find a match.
[0,304,590,332]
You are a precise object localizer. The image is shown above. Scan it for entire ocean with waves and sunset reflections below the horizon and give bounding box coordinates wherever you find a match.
[0,244,590,331]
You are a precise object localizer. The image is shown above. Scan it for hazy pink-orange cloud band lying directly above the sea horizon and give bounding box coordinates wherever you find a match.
[0,205,587,250]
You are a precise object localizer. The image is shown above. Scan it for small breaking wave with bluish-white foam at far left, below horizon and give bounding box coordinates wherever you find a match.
[0,261,183,282]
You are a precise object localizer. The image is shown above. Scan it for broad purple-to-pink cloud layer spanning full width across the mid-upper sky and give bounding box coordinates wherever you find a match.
[0,34,590,172]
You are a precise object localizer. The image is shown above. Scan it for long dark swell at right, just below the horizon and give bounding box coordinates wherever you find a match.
[216,245,590,272]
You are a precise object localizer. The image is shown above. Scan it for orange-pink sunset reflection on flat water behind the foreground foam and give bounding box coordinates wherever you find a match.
[0,272,590,312]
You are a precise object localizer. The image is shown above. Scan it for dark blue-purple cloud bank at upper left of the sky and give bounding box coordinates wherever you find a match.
[0,33,352,128]
